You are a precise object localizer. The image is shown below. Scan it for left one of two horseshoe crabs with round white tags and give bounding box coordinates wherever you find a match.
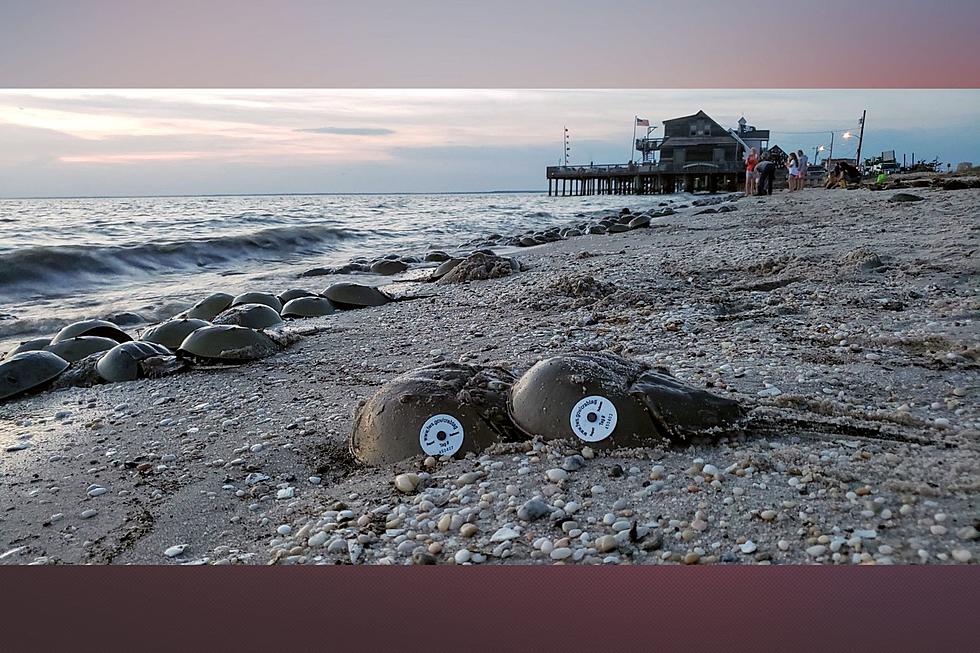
[348,363,515,465]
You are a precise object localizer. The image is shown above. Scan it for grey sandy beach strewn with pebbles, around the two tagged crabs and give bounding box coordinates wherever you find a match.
[0,188,980,564]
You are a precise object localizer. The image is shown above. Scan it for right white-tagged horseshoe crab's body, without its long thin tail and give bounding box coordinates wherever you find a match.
[508,353,744,447]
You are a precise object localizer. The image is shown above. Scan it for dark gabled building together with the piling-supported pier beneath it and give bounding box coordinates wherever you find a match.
[547,111,769,196]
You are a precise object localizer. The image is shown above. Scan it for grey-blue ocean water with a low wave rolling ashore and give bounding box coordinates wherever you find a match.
[0,193,665,351]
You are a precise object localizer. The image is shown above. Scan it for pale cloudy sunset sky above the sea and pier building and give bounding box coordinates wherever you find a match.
[0,89,980,197]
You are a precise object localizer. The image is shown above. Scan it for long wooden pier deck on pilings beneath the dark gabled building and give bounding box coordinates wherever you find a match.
[547,161,745,197]
